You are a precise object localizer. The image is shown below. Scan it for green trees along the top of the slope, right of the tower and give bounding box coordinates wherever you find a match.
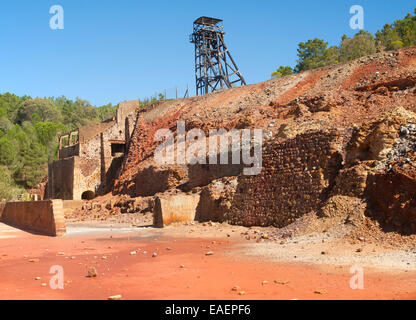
[272,8,416,78]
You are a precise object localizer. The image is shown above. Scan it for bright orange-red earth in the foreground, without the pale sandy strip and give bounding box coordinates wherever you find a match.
[0,224,416,300]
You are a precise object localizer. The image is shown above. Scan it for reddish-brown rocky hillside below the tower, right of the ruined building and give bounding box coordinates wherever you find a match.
[75,47,416,239]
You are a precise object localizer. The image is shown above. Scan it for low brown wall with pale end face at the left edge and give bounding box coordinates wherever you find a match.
[0,200,66,236]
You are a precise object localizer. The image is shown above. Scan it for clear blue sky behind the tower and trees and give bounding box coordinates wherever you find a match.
[0,0,416,105]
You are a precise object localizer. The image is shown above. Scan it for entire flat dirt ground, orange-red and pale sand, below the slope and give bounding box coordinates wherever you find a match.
[0,222,416,300]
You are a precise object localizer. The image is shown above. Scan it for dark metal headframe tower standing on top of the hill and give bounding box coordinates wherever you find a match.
[190,17,246,95]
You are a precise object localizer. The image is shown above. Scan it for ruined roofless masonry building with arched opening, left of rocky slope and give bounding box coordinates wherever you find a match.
[47,100,139,200]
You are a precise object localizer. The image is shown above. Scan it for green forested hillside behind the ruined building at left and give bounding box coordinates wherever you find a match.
[0,93,117,200]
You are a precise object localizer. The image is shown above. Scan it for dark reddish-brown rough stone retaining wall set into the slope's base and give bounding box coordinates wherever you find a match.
[227,131,342,227]
